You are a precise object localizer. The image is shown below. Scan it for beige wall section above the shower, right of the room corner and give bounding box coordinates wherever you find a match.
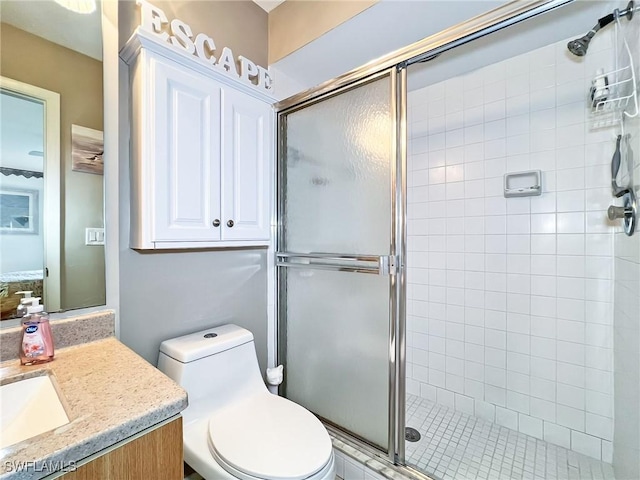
[269,0,378,65]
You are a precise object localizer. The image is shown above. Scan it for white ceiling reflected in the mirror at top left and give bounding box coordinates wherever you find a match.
[0,0,102,60]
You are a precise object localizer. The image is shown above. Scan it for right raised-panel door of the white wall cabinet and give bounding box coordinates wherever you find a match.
[221,89,273,240]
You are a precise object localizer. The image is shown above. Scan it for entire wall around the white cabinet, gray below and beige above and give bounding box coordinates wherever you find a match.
[119,2,267,372]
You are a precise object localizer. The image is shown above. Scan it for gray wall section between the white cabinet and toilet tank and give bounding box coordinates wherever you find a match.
[120,246,267,372]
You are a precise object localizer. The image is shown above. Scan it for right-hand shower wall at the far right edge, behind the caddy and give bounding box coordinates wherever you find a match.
[613,11,640,479]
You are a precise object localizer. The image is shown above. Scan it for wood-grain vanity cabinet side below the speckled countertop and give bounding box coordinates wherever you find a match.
[57,417,184,480]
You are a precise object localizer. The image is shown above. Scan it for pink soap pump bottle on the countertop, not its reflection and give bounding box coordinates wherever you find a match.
[20,297,54,365]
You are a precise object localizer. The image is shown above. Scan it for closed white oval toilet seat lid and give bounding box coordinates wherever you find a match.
[207,392,332,480]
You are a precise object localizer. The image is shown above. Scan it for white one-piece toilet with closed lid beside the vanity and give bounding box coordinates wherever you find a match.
[158,325,335,480]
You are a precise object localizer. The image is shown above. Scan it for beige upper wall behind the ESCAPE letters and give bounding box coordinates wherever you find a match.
[118,0,268,67]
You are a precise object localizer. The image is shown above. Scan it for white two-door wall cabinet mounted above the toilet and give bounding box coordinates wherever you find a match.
[121,36,274,249]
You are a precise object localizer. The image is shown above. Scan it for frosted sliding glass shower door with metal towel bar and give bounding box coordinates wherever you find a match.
[277,72,396,451]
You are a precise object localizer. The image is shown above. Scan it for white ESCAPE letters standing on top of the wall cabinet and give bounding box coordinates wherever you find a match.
[136,0,273,90]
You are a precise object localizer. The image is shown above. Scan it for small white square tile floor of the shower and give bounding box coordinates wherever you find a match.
[405,395,614,480]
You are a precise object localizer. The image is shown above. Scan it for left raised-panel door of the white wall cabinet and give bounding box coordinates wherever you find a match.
[147,58,221,242]
